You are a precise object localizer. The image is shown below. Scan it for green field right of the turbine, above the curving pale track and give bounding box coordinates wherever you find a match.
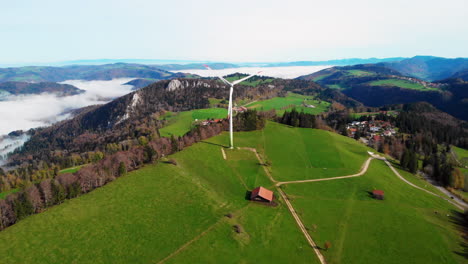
[209,122,370,181]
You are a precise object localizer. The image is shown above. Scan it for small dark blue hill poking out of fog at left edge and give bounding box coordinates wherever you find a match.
[0,82,84,96]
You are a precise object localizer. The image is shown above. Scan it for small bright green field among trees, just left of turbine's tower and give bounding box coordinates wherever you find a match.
[159,108,227,137]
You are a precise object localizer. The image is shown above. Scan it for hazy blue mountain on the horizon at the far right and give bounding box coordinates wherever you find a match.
[378,56,468,81]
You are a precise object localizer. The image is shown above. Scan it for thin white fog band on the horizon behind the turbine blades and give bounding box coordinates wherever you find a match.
[174,66,332,79]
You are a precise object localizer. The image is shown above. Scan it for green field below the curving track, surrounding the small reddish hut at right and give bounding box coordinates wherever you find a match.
[284,160,466,264]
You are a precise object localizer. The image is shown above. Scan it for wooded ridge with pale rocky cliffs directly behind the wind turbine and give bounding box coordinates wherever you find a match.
[7,79,334,164]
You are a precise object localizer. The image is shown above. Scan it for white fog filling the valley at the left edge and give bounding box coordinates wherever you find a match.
[0,78,134,163]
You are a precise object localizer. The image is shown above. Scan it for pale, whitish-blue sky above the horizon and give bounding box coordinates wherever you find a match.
[0,0,468,64]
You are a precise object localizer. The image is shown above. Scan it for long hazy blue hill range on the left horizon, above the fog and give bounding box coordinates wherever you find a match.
[0,63,194,82]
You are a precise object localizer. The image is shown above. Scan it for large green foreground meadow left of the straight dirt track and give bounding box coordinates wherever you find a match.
[0,136,318,263]
